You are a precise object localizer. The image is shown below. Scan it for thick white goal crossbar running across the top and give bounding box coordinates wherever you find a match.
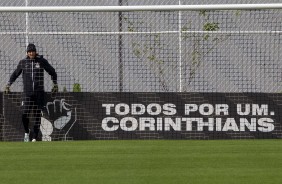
[0,3,282,12]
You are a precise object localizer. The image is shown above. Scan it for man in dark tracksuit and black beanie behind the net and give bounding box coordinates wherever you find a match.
[5,44,58,142]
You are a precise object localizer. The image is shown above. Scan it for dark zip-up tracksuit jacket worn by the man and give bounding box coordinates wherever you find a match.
[9,55,57,110]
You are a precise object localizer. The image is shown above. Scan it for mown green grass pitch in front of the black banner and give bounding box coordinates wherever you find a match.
[0,140,282,184]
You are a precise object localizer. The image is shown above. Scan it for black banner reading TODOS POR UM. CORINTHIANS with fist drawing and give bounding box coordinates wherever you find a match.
[3,93,282,141]
